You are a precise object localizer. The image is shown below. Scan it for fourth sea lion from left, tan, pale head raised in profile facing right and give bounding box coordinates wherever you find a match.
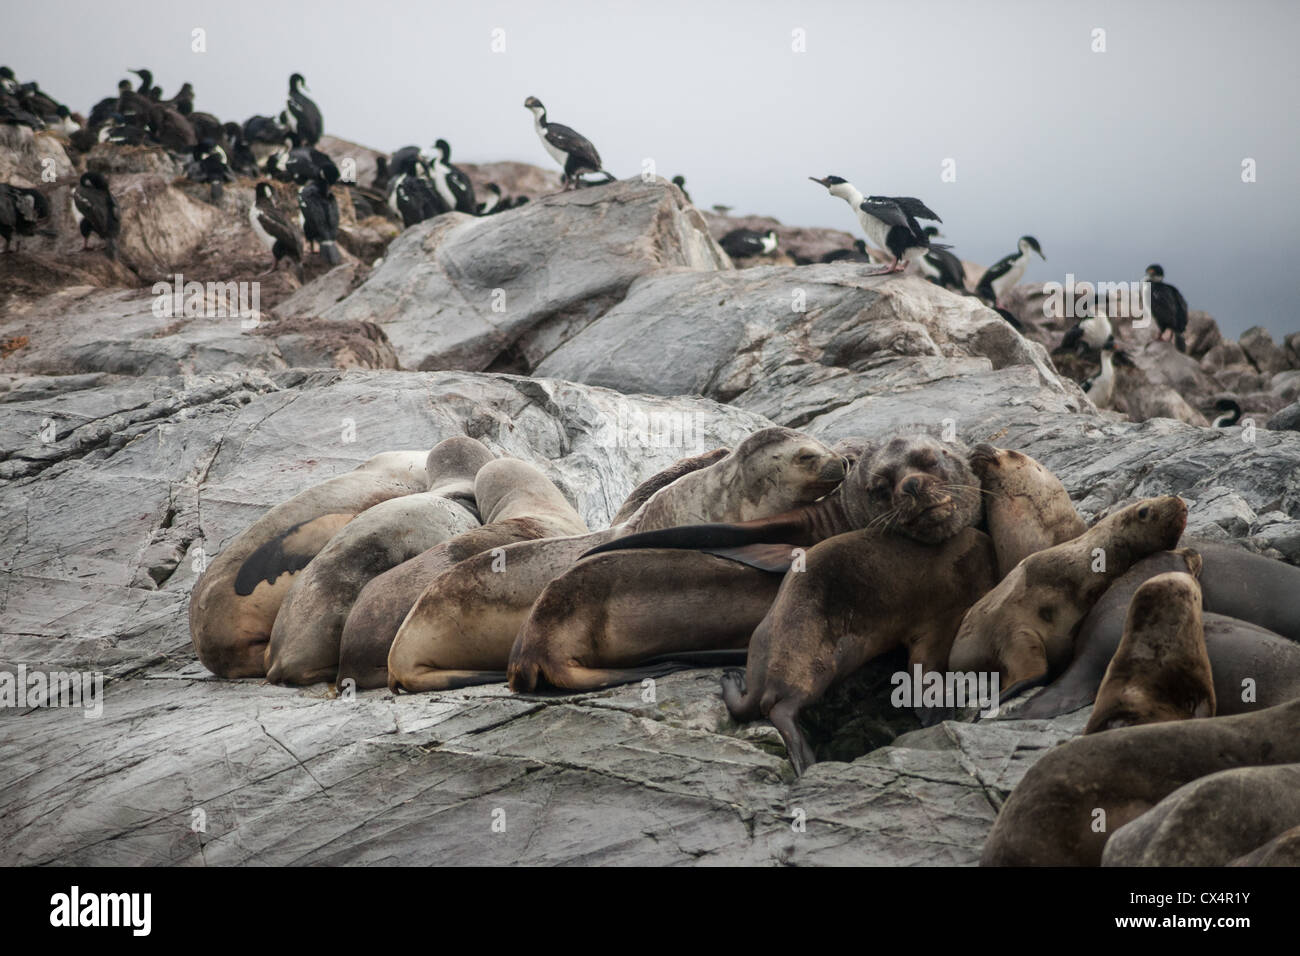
[389,428,845,691]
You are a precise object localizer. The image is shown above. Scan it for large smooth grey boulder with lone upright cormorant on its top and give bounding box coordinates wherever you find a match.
[321,179,729,373]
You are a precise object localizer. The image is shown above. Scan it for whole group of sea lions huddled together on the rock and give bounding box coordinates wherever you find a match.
[190,428,1300,864]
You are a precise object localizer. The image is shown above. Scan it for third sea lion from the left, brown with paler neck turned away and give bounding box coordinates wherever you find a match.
[337,458,588,688]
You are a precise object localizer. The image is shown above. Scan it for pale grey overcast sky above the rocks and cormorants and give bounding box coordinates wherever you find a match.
[12,0,1300,338]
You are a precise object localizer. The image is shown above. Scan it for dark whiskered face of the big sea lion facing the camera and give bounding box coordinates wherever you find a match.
[841,434,980,544]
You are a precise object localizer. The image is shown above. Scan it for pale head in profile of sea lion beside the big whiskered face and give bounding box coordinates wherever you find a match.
[732,427,849,514]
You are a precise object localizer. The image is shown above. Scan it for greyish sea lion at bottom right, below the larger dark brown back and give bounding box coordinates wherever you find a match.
[1101,763,1300,866]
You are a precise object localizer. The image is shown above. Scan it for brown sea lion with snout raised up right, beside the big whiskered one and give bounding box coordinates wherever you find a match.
[948,496,1187,689]
